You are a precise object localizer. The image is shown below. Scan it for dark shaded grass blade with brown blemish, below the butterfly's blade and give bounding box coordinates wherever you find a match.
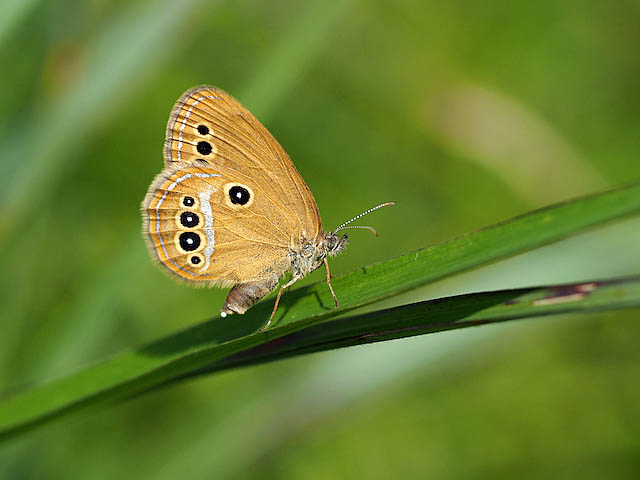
[192,276,640,378]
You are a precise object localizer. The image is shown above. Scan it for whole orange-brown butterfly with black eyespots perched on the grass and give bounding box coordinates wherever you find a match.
[142,86,393,330]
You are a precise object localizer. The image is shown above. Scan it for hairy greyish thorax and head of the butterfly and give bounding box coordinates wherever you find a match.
[289,231,348,278]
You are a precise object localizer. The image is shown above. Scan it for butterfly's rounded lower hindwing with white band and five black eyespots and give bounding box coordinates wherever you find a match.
[143,163,291,285]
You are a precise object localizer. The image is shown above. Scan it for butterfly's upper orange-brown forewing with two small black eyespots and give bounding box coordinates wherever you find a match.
[164,86,321,240]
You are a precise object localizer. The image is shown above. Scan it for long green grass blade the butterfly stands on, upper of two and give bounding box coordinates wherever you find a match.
[0,185,640,436]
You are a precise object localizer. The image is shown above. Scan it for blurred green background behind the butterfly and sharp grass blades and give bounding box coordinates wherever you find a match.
[0,0,640,479]
